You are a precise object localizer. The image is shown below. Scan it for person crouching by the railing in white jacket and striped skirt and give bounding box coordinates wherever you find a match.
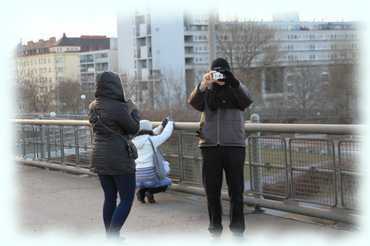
[133,117,174,203]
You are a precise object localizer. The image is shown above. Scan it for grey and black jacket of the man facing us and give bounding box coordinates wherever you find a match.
[188,82,252,147]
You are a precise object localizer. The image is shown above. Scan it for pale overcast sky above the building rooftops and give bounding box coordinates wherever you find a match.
[5,0,368,41]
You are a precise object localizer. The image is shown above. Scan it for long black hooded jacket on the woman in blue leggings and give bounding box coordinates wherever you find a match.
[89,72,140,175]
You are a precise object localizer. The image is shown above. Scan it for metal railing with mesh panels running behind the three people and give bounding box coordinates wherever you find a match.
[14,119,363,222]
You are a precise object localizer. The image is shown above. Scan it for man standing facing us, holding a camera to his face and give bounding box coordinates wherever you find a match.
[188,58,252,236]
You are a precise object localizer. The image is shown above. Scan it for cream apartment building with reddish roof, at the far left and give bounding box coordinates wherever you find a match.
[16,33,117,111]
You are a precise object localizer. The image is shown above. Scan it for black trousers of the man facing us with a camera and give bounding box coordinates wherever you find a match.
[201,146,245,233]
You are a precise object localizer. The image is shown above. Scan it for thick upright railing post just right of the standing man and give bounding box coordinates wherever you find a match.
[250,113,263,211]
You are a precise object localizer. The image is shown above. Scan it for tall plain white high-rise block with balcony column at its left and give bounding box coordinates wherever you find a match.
[118,11,185,106]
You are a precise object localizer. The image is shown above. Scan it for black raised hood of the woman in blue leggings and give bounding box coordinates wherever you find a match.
[95,72,125,102]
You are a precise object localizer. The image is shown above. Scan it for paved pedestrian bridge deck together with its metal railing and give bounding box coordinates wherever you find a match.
[14,119,362,234]
